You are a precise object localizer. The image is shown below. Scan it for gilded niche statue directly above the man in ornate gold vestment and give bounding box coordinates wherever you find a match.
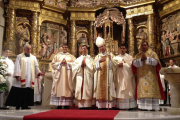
[136,29,147,50]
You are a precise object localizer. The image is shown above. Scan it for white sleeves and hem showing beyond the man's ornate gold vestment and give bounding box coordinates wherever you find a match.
[133,57,160,110]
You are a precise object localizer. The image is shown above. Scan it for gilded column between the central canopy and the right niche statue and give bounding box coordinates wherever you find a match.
[128,18,134,57]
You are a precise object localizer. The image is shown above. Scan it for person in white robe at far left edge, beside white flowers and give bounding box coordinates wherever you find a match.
[1,48,14,92]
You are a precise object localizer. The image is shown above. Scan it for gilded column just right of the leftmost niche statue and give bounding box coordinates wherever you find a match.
[31,12,38,56]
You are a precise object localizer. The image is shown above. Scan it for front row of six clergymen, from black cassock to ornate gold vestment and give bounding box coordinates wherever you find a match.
[1,37,165,111]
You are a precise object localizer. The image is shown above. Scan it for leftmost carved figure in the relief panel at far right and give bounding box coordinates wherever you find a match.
[161,31,170,56]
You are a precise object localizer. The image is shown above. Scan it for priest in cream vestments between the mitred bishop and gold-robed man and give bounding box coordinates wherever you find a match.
[114,44,137,110]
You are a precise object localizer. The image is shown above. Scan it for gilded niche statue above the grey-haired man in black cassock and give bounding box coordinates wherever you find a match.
[16,23,30,53]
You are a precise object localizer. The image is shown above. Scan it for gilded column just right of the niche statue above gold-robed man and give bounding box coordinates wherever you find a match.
[147,14,156,50]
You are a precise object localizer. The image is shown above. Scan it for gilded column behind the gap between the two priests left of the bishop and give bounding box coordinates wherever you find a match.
[70,20,77,57]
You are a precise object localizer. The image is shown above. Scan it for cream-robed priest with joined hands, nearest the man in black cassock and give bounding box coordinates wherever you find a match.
[50,44,76,109]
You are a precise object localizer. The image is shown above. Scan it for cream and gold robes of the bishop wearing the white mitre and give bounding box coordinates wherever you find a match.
[93,52,116,108]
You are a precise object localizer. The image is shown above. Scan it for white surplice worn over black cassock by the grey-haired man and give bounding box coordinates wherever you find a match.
[13,54,40,88]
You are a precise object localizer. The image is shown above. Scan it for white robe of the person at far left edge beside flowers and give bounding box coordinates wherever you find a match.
[1,56,14,91]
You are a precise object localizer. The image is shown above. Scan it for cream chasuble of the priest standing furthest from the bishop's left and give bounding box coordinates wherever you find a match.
[51,52,76,97]
